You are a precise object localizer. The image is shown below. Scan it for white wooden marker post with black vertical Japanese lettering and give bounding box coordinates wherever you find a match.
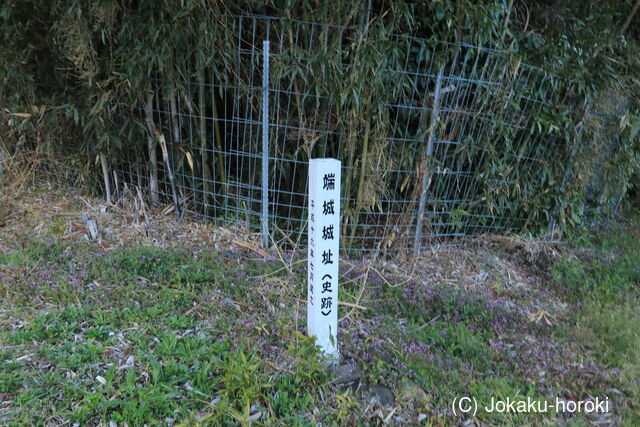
[307,159,340,359]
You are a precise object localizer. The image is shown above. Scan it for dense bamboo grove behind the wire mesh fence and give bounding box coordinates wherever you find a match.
[0,0,640,249]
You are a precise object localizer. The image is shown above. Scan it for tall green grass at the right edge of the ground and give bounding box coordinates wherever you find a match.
[553,211,640,425]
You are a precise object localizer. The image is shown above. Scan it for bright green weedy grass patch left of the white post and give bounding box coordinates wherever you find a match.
[0,240,327,426]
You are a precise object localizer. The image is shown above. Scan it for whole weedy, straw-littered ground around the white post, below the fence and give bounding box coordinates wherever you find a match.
[0,193,640,426]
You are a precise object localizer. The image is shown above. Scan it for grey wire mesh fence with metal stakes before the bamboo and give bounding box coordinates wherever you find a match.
[118,16,572,251]
